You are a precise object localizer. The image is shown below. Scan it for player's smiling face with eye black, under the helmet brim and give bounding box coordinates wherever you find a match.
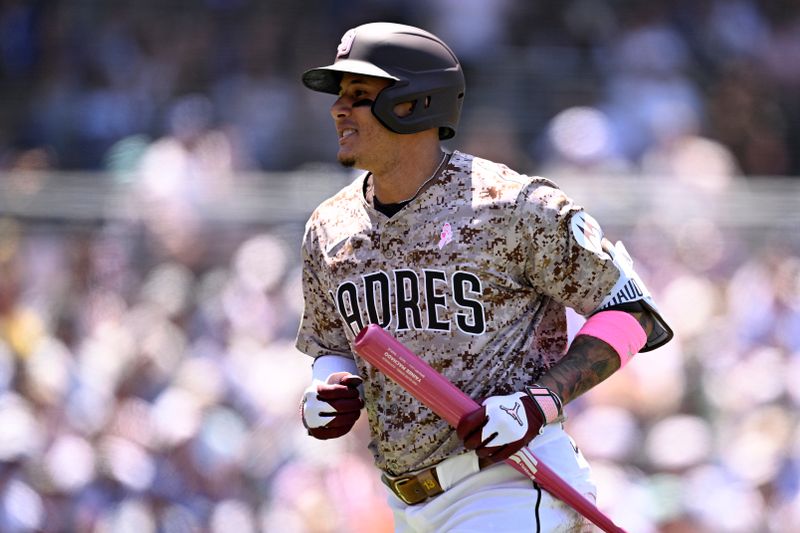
[331,74,405,170]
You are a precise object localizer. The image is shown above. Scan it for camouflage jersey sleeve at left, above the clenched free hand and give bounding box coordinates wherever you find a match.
[295,218,353,359]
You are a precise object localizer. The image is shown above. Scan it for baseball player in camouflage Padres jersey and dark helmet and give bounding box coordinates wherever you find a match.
[297,23,672,532]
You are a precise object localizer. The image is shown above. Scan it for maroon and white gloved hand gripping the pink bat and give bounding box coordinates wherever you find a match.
[456,386,561,463]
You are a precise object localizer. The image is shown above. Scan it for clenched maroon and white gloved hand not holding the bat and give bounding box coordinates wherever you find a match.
[300,372,364,439]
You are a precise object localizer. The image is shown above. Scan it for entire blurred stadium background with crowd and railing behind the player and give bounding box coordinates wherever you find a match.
[0,0,800,533]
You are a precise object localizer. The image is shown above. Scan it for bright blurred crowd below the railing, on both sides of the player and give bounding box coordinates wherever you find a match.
[0,180,800,533]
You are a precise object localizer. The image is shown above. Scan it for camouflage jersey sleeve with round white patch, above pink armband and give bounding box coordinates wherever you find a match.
[518,181,619,316]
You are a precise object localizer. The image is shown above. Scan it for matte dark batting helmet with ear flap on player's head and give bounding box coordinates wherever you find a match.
[303,22,464,139]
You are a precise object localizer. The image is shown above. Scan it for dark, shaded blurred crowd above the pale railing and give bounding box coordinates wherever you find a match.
[0,0,800,180]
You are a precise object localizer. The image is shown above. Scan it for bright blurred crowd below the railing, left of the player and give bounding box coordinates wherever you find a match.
[0,209,391,533]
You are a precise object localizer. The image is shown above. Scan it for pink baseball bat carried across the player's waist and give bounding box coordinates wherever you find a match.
[355,324,625,533]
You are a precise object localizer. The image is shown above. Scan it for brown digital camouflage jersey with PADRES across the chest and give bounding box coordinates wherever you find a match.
[297,152,619,475]
